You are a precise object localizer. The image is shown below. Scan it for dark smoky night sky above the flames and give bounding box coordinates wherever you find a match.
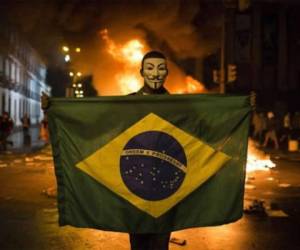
[0,0,220,64]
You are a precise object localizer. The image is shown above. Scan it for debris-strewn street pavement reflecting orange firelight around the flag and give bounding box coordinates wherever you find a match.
[0,132,300,250]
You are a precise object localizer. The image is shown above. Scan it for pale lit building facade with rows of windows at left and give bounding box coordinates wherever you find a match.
[0,21,51,126]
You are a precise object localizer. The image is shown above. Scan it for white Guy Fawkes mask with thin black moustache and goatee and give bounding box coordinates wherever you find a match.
[141,58,168,89]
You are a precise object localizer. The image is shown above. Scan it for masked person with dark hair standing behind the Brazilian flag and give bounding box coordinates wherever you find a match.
[130,51,171,250]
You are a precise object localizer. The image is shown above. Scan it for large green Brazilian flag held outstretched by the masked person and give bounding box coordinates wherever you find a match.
[48,94,250,233]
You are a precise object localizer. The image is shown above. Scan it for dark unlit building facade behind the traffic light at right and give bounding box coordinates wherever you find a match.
[226,0,300,110]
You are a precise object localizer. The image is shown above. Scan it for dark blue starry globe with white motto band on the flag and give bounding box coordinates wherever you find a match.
[120,131,187,201]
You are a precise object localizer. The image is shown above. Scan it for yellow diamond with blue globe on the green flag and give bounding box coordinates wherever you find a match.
[76,113,230,218]
